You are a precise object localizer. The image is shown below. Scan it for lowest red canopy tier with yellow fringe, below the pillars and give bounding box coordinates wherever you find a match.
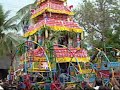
[34,46,89,63]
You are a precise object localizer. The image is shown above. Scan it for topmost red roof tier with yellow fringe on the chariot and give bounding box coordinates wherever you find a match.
[32,0,74,18]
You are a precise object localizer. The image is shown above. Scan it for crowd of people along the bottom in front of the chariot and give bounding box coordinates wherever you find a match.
[0,70,120,90]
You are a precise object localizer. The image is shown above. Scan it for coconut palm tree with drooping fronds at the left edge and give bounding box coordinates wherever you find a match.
[0,5,23,69]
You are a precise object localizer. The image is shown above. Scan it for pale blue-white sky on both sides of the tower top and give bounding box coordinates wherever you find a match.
[0,0,82,16]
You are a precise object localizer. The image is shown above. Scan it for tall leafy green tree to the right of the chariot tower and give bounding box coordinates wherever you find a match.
[74,0,120,48]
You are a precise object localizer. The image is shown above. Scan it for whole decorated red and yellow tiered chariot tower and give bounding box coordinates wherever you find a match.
[17,0,89,82]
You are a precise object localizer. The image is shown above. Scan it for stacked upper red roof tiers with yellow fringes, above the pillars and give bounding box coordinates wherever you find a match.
[24,0,83,37]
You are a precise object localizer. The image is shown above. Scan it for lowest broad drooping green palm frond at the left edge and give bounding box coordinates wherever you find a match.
[0,33,24,56]
